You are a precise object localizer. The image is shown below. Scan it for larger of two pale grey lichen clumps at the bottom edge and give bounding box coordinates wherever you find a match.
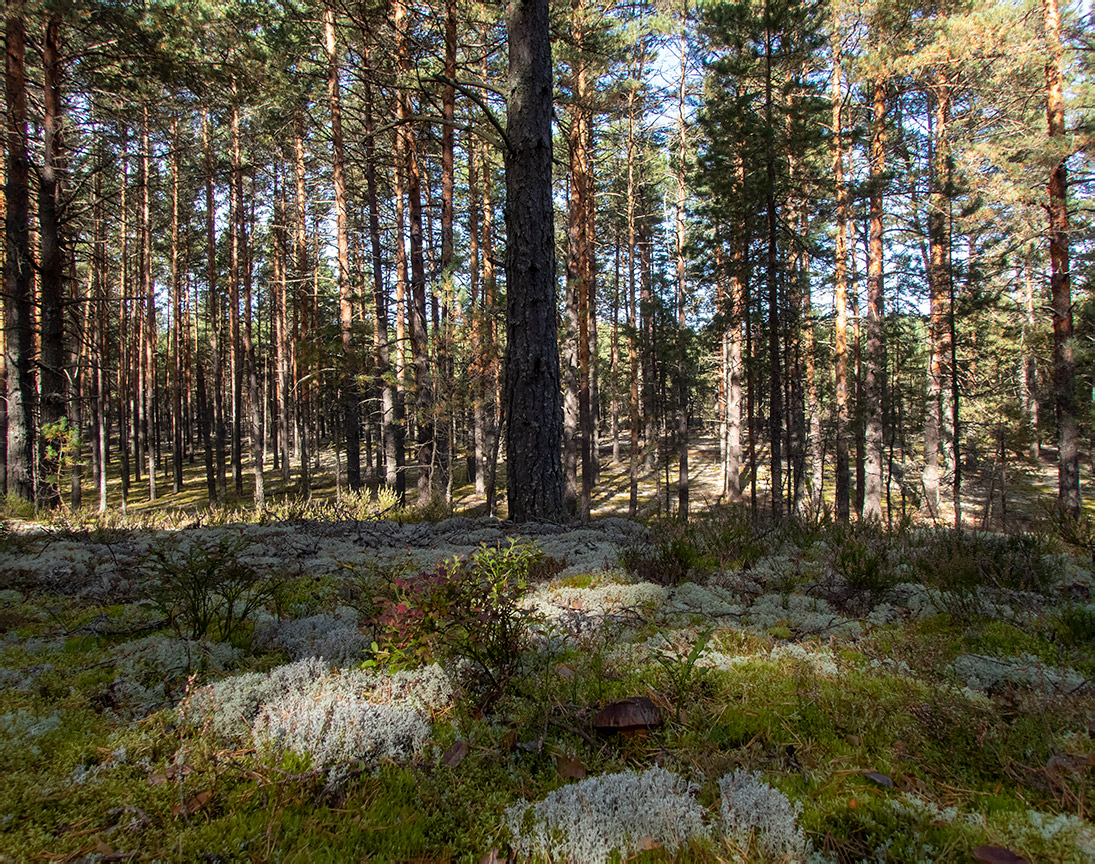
[504,768,707,864]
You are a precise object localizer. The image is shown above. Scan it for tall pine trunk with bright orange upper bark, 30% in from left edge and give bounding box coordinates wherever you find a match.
[323,3,361,492]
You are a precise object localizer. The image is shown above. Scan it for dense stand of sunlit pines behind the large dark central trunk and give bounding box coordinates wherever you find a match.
[0,0,1095,523]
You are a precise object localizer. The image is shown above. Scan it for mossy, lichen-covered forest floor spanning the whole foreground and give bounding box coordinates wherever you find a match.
[0,443,1095,864]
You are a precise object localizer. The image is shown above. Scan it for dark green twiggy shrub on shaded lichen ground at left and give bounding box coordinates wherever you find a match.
[147,537,276,641]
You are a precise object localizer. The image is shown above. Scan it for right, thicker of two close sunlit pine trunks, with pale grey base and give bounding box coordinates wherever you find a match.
[863,78,886,519]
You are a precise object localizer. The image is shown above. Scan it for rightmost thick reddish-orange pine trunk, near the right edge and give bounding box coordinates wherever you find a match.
[1042,0,1080,516]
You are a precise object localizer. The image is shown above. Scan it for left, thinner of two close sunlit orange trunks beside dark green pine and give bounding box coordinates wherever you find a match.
[832,37,851,522]
